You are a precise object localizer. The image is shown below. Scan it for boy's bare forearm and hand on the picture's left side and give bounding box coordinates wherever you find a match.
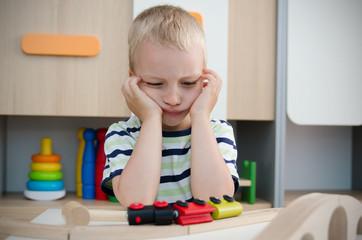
[112,77,162,206]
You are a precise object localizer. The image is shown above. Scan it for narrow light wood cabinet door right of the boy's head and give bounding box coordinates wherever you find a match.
[227,0,277,120]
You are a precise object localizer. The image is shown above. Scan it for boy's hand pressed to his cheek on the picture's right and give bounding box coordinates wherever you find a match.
[190,69,222,119]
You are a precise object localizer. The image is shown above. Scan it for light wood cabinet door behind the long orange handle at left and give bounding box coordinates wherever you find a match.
[0,0,132,116]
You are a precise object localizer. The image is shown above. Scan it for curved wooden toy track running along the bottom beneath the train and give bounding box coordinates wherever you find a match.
[0,209,280,240]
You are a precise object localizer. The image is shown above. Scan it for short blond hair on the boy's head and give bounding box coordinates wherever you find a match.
[128,5,207,72]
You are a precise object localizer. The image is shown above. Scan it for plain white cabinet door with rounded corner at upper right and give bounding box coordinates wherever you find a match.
[286,0,362,126]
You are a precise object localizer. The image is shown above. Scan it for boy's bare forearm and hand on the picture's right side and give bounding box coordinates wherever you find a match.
[190,70,234,199]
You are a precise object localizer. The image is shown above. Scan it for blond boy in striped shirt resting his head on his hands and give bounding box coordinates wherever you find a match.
[102,5,239,206]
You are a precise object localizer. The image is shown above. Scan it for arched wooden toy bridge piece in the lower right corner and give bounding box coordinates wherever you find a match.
[255,193,362,240]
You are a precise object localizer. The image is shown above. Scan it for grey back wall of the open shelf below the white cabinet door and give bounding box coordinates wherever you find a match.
[285,119,352,190]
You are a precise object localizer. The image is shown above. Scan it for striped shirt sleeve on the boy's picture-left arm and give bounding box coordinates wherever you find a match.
[101,122,139,196]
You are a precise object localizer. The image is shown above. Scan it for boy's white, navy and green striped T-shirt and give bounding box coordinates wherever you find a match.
[101,115,239,203]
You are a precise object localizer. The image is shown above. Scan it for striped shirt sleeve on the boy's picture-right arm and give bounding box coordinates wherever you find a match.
[211,120,239,193]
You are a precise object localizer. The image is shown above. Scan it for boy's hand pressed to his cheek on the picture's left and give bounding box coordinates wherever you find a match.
[122,76,162,122]
